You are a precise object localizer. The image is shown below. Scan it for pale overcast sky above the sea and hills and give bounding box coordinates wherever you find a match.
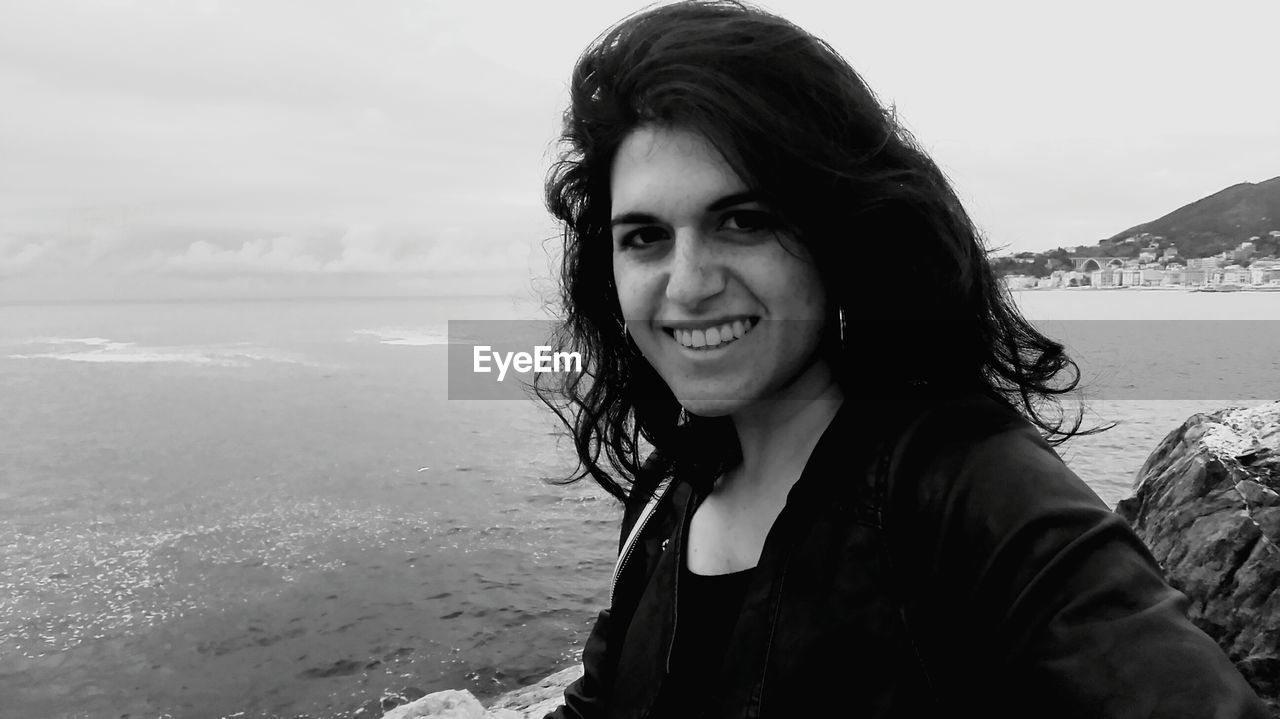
[0,0,1280,301]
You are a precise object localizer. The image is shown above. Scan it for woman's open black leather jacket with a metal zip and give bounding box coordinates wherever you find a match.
[548,397,1267,719]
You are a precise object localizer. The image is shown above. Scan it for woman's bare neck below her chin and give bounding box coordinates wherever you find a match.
[722,363,845,498]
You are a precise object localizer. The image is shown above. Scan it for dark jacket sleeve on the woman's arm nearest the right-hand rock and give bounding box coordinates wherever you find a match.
[910,422,1268,719]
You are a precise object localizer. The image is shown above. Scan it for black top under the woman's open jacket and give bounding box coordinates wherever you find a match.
[650,567,754,719]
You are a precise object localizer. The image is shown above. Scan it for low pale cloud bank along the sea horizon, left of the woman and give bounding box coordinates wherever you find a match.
[0,224,547,303]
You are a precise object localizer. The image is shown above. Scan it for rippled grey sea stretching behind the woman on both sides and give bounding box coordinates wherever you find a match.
[0,289,1280,719]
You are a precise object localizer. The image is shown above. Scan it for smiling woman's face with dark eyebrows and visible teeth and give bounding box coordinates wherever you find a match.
[611,127,832,416]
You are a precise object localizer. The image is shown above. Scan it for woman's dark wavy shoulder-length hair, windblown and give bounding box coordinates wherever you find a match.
[535,0,1097,499]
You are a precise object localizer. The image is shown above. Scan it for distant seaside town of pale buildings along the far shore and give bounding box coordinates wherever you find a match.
[1001,230,1280,292]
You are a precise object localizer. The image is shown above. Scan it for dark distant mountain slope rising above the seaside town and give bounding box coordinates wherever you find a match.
[1107,177,1280,257]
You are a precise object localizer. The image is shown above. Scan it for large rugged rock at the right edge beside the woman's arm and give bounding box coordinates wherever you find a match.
[1116,402,1280,716]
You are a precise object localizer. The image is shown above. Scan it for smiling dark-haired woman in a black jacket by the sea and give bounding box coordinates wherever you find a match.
[540,1,1265,719]
